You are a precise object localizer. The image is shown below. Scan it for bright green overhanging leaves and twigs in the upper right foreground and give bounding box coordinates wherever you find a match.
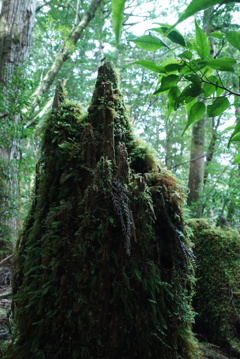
[112,0,240,163]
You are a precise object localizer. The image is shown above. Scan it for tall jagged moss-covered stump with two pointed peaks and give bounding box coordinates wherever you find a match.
[6,63,201,359]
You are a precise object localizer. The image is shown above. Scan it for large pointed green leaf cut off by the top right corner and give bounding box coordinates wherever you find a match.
[169,0,240,31]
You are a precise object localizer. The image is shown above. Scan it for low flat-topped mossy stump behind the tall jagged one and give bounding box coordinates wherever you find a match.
[189,219,240,358]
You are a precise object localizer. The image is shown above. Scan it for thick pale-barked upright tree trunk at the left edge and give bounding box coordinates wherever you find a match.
[0,0,36,250]
